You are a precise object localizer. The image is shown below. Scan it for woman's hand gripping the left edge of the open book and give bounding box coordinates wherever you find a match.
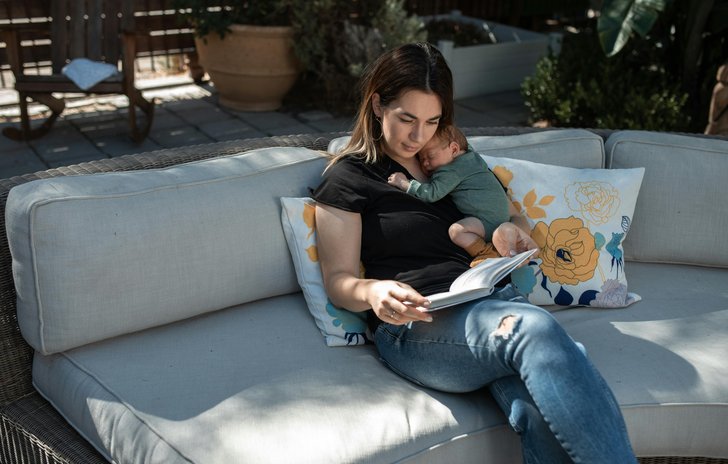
[367,280,432,325]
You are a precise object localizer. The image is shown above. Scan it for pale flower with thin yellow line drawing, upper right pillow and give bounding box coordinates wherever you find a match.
[564,181,620,224]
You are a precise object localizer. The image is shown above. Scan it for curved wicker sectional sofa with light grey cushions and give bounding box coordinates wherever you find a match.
[0,128,728,464]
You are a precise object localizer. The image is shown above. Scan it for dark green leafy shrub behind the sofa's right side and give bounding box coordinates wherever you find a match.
[522,30,690,131]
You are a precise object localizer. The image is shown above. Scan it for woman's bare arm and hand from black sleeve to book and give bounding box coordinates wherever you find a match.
[316,204,431,324]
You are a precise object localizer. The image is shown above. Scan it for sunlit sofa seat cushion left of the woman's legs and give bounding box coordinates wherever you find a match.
[33,293,519,464]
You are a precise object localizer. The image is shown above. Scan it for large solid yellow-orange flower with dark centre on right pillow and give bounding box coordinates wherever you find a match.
[531,216,599,285]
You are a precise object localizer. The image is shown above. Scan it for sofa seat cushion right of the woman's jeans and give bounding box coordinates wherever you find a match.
[554,262,728,458]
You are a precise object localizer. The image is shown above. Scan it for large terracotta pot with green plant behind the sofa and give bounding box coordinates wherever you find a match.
[173,0,301,111]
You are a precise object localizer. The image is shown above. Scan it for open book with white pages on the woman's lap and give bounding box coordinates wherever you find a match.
[427,249,536,311]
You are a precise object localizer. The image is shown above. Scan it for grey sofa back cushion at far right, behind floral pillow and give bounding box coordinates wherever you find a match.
[606,131,728,267]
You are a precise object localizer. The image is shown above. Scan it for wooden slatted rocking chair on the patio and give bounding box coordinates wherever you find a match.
[0,0,154,142]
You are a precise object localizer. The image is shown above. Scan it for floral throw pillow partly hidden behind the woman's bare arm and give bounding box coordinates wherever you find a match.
[281,197,372,346]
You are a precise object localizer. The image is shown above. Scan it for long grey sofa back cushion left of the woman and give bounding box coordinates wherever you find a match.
[6,148,325,354]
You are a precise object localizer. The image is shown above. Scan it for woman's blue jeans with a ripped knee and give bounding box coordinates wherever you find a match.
[375,285,637,464]
